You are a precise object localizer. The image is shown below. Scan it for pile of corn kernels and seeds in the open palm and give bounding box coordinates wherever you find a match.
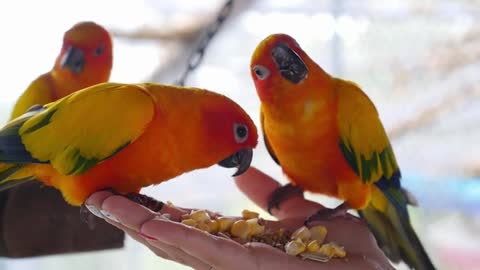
[181,210,347,262]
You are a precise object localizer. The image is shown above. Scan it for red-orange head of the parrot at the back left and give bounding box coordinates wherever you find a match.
[54,22,113,86]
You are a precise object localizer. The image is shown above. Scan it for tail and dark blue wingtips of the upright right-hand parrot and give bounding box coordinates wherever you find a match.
[358,173,435,270]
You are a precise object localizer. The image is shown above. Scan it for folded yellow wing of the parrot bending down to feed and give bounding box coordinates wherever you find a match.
[0,83,155,175]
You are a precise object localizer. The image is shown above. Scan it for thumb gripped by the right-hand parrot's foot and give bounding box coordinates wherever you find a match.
[235,167,324,219]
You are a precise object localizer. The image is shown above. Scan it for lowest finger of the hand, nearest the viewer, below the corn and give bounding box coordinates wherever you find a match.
[140,219,255,270]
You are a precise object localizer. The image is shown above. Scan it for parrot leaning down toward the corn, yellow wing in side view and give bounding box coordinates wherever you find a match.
[0,83,258,205]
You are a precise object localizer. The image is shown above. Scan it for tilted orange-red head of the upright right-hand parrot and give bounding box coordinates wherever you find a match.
[250,34,326,103]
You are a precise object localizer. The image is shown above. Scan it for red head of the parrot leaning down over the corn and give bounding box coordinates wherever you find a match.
[204,95,258,176]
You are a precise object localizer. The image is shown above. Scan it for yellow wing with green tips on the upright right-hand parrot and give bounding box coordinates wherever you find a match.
[337,79,399,186]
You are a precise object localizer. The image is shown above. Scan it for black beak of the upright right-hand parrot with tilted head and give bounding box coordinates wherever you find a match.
[272,43,308,84]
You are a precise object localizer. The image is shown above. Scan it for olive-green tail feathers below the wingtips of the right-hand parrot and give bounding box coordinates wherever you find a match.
[358,192,435,270]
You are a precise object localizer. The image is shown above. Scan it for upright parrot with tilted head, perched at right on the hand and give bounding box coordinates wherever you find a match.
[250,34,435,270]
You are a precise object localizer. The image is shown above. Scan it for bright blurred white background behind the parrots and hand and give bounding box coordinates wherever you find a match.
[0,0,480,270]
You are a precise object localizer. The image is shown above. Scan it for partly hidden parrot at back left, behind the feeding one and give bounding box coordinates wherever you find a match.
[10,22,113,119]
